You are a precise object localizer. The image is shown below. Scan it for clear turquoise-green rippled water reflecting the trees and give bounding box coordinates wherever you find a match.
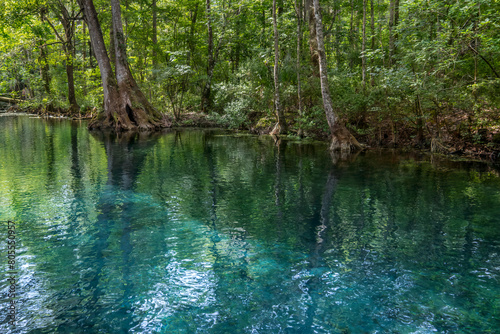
[0,116,500,333]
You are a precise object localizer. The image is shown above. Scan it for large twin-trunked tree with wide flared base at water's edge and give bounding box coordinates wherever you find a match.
[78,0,164,131]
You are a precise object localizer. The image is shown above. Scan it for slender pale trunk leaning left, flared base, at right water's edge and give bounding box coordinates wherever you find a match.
[313,0,362,152]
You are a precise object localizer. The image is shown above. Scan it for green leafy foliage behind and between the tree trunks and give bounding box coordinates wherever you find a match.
[0,0,500,147]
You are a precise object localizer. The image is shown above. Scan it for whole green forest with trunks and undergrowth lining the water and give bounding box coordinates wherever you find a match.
[0,0,500,155]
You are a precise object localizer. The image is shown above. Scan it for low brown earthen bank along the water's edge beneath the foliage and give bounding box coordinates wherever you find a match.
[6,105,500,163]
